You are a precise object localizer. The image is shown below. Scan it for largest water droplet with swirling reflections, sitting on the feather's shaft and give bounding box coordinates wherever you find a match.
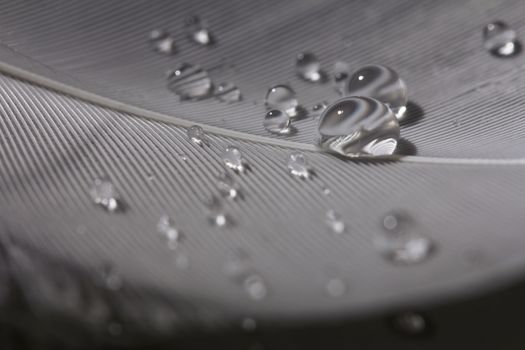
[319,97,400,157]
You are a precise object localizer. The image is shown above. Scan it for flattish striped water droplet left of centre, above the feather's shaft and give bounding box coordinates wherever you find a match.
[167,63,213,100]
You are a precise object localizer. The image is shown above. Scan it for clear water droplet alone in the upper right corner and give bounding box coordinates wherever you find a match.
[483,21,521,57]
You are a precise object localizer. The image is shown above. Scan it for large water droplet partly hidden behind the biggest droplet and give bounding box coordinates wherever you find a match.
[346,65,408,119]
